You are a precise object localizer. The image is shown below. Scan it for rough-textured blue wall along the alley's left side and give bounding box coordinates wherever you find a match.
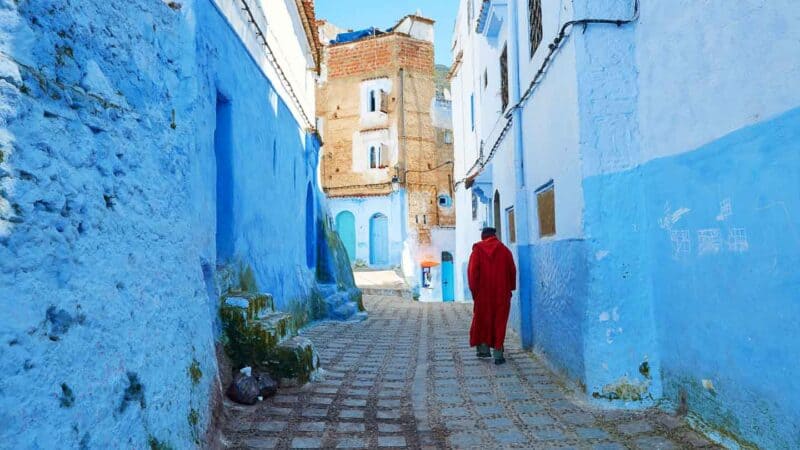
[0,0,352,449]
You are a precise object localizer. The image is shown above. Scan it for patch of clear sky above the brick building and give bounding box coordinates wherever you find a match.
[314,0,459,66]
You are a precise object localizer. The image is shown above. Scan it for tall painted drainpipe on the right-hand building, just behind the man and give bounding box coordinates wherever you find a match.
[508,0,533,349]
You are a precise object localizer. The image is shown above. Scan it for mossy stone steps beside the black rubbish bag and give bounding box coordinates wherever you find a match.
[220,292,319,386]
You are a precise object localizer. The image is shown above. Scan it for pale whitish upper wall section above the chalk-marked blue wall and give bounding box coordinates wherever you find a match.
[636,0,800,161]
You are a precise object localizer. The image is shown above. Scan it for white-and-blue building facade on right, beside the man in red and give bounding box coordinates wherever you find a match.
[451,0,800,448]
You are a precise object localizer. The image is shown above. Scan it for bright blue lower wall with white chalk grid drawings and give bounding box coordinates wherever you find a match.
[644,109,800,448]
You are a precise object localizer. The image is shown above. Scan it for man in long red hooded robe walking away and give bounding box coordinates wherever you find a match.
[468,228,517,365]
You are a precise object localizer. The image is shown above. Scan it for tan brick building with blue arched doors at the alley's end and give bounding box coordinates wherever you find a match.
[317,15,455,300]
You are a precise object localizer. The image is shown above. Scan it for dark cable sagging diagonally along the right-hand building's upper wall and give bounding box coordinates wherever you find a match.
[454,0,639,189]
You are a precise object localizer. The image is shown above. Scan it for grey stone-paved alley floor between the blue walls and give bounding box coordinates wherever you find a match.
[224,296,715,450]
